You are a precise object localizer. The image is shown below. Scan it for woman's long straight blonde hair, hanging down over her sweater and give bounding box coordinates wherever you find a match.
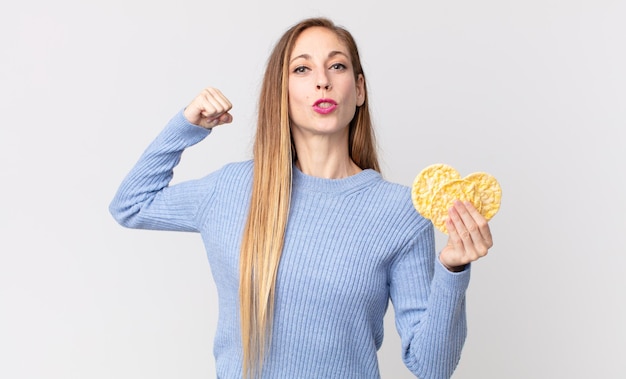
[239,18,379,378]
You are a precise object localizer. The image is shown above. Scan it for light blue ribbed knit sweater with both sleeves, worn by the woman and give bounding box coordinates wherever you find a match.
[110,111,469,379]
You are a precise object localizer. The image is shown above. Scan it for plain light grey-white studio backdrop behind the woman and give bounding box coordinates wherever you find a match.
[0,0,626,379]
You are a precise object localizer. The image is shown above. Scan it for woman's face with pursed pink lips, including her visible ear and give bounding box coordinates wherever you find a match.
[289,27,365,141]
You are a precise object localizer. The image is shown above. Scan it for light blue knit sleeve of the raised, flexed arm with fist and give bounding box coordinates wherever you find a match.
[109,110,216,232]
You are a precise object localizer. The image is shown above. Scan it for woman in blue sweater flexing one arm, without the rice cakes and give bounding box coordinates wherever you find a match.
[110,18,492,379]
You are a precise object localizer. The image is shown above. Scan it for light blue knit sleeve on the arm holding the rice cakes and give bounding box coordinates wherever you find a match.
[390,224,470,379]
